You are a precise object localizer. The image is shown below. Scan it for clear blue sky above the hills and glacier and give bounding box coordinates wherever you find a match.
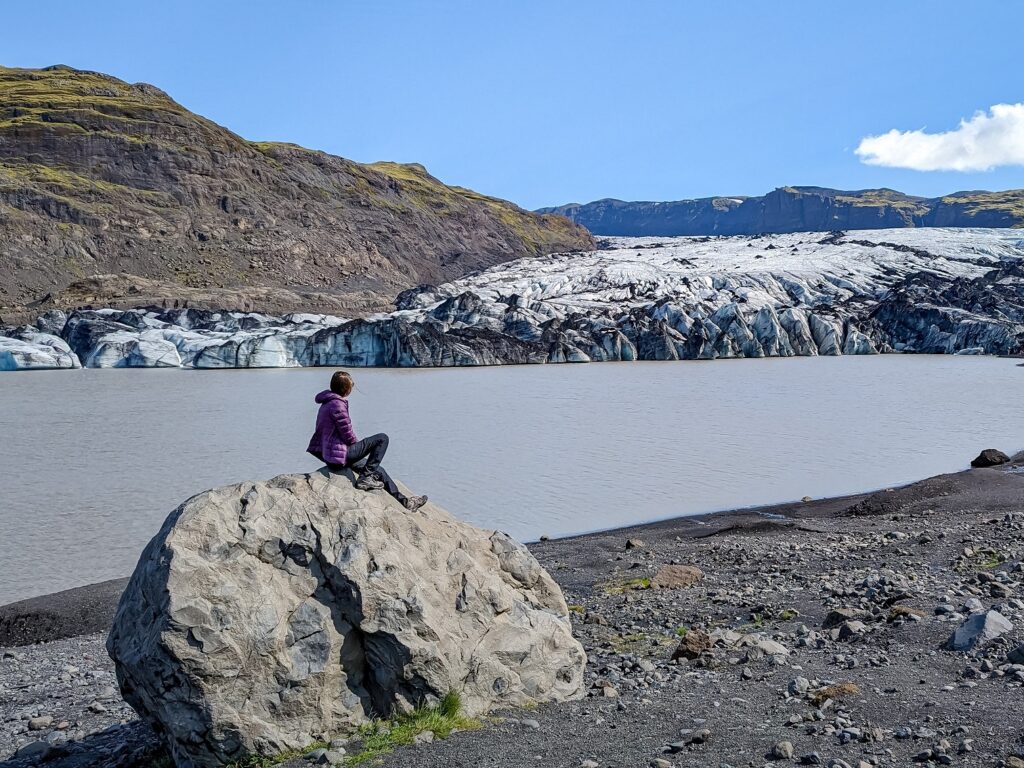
[0,0,1024,208]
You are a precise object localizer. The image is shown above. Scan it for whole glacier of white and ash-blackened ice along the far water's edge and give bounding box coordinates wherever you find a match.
[0,228,1024,370]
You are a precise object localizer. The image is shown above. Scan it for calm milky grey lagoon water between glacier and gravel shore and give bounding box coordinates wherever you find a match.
[0,355,1024,604]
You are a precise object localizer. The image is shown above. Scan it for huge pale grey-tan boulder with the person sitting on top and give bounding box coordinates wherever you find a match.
[106,469,586,768]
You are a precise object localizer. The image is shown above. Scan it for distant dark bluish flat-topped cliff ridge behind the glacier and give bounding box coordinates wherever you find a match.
[541,186,1024,237]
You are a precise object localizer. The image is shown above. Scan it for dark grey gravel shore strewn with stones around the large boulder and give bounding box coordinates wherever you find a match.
[0,454,1024,768]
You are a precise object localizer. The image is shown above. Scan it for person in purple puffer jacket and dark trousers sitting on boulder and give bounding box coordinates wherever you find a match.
[306,371,427,511]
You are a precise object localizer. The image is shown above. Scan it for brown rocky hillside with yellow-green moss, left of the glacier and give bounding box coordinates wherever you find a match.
[0,67,593,311]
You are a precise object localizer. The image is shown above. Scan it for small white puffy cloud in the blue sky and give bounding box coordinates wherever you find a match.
[854,103,1024,171]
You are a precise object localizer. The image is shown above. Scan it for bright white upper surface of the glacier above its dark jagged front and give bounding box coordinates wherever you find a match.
[425,228,1024,309]
